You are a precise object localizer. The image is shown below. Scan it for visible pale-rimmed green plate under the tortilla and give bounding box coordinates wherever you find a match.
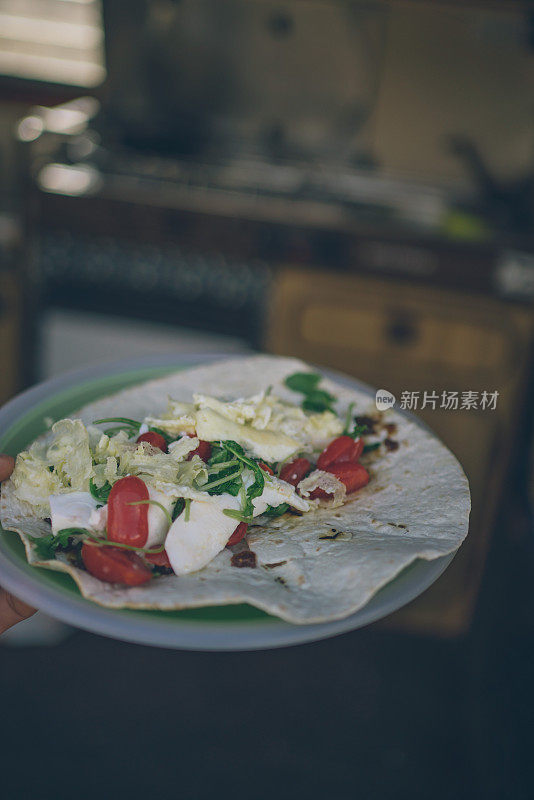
[0,353,455,650]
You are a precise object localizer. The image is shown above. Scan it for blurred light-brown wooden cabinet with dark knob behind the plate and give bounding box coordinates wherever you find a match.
[266,268,534,634]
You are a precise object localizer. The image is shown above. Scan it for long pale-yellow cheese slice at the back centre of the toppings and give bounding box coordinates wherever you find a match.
[197,408,300,461]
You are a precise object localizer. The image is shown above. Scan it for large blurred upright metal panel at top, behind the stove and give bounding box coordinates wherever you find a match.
[99,0,386,163]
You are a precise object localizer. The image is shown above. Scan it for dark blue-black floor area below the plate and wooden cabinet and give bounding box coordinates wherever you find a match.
[0,496,534,800]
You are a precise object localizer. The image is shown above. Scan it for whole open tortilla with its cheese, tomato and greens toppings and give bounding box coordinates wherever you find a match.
[0,356,469,622]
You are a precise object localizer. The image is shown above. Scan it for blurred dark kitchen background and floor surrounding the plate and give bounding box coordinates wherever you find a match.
[0,0,534,800]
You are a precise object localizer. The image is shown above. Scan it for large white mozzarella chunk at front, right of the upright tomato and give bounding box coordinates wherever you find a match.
[165,494,241,575]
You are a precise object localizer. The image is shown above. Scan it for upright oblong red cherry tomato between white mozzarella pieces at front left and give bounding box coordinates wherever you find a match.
[108,475,149,547]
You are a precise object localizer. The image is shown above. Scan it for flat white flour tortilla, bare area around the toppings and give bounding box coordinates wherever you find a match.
[0,355,470,624]
